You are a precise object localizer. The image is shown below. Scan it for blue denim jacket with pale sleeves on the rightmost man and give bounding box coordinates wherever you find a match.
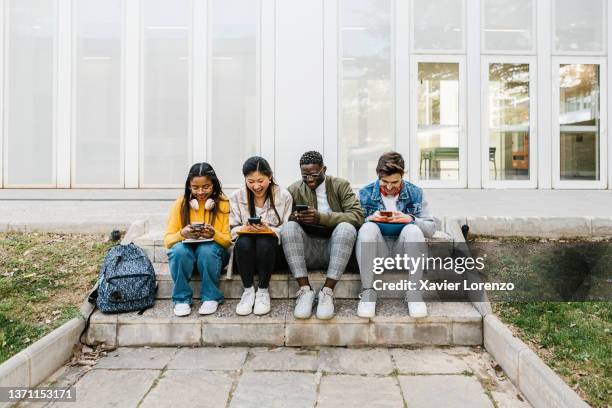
[359,180,436,238]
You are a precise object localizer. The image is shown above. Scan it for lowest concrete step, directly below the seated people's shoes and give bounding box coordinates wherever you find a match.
[87,299,482,347]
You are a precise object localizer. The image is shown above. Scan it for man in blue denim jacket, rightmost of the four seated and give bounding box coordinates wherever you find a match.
[355,152,436,317]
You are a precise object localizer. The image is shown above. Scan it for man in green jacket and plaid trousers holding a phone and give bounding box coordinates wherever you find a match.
[281,151,363,319]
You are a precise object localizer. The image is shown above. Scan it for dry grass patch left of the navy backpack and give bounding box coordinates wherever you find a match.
[0,233,113,363]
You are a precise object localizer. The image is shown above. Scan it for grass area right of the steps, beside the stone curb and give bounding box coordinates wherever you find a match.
[469,237,612,407]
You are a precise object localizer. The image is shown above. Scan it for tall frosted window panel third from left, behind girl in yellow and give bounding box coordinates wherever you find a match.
[141,0,192,186]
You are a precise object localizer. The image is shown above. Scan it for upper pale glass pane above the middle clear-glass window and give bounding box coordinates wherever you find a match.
[482,0,535,51]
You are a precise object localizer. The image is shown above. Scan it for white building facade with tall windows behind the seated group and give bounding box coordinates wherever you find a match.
[0,0,612,189]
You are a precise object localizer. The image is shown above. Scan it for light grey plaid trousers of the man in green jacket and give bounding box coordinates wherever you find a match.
[281,221,357,280]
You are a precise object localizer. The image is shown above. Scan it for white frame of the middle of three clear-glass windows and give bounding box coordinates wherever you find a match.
[480,56,538,188]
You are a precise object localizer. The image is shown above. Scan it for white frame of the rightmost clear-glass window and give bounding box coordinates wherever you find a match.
[551,56,608,189]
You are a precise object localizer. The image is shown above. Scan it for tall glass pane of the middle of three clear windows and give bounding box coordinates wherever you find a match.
[486,63,530,180]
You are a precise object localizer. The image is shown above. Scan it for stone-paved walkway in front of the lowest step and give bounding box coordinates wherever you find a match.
[20,347,530,408]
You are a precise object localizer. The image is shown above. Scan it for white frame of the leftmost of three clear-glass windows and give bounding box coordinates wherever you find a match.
[409,55,468,188]
